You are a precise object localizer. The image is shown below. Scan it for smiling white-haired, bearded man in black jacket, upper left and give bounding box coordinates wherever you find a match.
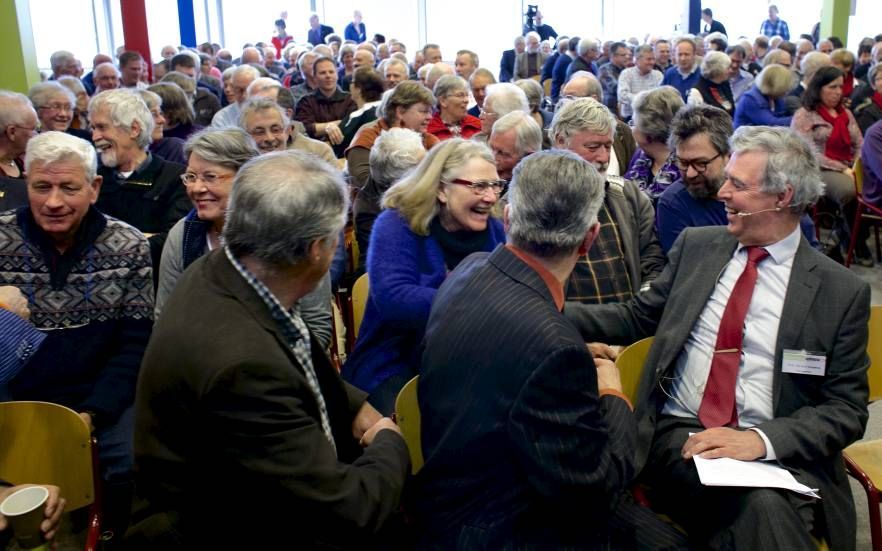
[89,90,192,266]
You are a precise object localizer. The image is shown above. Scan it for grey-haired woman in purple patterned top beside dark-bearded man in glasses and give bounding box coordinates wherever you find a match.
[625,86,684,207]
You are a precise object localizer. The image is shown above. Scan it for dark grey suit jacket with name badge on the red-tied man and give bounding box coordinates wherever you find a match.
[566,226,870,549]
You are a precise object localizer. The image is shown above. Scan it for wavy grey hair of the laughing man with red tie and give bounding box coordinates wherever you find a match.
[729,126,824,214]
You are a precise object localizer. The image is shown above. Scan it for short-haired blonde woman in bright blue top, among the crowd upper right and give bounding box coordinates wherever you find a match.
[733,63,794,128]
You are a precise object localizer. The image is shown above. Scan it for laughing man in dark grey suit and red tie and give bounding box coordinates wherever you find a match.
[567,127,870,549]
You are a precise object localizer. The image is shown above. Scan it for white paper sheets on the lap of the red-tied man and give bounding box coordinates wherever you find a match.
[692,455,821,499]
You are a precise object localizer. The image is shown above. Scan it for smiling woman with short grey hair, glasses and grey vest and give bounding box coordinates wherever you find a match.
[155,128,260,318]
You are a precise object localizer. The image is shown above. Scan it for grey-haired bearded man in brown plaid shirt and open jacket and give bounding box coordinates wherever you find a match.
[549,98,665,304]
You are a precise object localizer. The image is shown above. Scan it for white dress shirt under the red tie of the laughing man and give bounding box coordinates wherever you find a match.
[662,226,801,459]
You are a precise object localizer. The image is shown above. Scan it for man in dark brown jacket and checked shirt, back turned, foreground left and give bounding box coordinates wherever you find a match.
[130,151,410,549]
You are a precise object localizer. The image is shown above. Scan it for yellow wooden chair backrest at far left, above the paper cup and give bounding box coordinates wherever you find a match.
[0,402,95,511]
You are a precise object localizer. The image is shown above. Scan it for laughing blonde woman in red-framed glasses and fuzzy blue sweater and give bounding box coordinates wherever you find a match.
[343,139,505,414]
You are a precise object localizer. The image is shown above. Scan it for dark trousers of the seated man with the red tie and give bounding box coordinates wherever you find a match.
[643,416,815,550]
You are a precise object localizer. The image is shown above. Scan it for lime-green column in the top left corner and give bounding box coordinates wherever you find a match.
[0,0,39,94]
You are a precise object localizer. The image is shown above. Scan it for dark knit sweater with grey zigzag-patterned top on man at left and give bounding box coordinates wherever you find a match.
[0,207,153,427]
